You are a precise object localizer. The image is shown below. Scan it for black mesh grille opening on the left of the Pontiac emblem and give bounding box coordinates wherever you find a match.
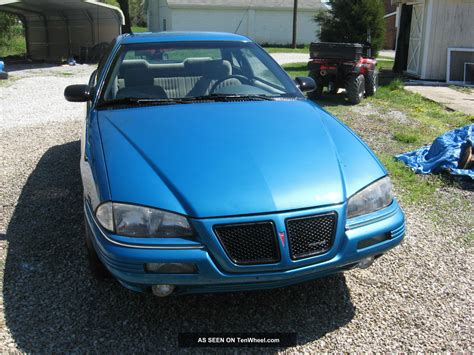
[214,221,280,265]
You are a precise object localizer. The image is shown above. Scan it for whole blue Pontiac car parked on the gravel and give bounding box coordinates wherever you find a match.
[65,32,405,296]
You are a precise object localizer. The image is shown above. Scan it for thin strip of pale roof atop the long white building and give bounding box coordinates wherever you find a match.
[167,0,324,10]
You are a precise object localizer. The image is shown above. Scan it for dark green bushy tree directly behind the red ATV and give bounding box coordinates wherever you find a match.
[314,0,385,55]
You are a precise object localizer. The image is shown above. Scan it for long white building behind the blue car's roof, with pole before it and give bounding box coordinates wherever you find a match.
[148,0,326,44]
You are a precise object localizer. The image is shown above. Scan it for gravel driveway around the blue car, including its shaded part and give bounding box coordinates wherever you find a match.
[0,67,474,353]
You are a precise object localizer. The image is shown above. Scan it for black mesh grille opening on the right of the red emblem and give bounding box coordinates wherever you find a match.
[286,212,337,260]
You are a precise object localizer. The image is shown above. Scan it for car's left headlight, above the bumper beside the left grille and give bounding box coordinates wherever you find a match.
[95,202,193,238]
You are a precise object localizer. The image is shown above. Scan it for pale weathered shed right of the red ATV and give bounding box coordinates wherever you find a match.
[392,0,474,83]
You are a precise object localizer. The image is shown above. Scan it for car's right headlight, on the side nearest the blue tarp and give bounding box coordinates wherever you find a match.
[347,176,393,218]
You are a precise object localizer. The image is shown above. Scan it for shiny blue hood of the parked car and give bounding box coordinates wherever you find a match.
[98,100,385,218]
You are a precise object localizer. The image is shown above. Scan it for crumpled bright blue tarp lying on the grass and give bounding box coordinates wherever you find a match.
[395,124,474,180]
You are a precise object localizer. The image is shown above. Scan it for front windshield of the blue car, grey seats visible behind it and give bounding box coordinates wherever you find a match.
[100,41,301,104]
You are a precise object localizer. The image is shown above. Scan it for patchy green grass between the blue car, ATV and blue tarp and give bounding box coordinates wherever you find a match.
[284,61,474,204]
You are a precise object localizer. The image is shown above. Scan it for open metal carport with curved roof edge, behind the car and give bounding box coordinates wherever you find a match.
[0,0,124,61]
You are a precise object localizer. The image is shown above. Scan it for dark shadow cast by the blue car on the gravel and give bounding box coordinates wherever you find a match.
[3,142,354,353]
